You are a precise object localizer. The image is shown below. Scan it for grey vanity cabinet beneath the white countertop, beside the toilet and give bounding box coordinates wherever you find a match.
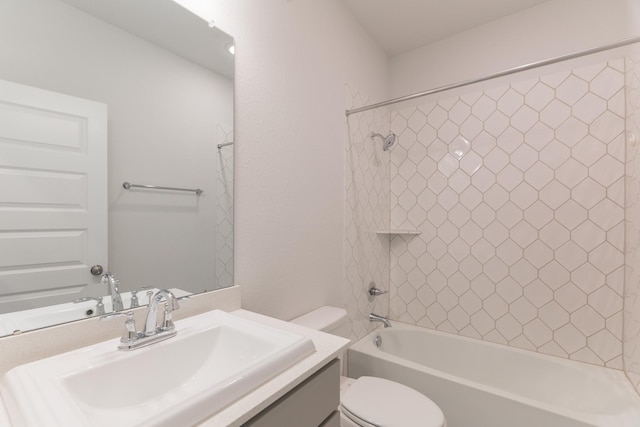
[243,359,340,427]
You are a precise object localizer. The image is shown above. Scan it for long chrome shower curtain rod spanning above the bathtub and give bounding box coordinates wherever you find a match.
[345,37,640,117]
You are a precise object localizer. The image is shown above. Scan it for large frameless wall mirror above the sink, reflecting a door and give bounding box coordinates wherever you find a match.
[0,0,234,335]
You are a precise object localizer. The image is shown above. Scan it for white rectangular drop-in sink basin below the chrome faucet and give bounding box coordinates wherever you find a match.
[0,310,315,427]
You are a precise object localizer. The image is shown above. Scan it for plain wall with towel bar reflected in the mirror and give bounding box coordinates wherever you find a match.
[0,0,233,291]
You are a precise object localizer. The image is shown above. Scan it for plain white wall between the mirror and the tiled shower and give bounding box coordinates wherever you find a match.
[172,0,387,319]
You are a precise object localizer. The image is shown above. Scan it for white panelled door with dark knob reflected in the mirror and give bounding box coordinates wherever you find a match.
[0,80,107,313]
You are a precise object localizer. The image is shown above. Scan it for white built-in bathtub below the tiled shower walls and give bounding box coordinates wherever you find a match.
[347,322,640,427]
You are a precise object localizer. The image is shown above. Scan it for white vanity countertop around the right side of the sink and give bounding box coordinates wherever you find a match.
[198,310,349,427]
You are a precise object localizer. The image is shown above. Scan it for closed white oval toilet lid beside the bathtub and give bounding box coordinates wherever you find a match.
[340,377,444,427]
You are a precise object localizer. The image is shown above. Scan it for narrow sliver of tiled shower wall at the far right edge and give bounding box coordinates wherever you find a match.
[623,56,640,391]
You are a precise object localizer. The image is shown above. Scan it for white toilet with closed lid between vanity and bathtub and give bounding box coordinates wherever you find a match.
[291,306,446,427]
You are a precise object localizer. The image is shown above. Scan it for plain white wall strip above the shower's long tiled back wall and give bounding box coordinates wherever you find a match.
[390,0,640,97]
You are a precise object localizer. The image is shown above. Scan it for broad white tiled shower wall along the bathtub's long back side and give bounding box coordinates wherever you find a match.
[388,59,628,372]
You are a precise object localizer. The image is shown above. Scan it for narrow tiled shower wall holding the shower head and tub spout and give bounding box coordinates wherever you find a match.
[343,85,390,341]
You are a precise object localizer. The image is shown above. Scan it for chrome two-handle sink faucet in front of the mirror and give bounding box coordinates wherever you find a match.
[100,289,180,350]
